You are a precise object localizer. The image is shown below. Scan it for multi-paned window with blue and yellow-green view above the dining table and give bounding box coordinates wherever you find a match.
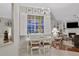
[27,15,44,33]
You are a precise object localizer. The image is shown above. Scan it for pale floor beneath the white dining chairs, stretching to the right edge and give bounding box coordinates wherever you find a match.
[19,41,79,56]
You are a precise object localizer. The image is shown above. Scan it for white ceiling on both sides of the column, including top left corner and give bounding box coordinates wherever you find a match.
[0,3,79,21]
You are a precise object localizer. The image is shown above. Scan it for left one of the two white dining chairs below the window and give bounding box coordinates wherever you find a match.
[30,40,40,55]
